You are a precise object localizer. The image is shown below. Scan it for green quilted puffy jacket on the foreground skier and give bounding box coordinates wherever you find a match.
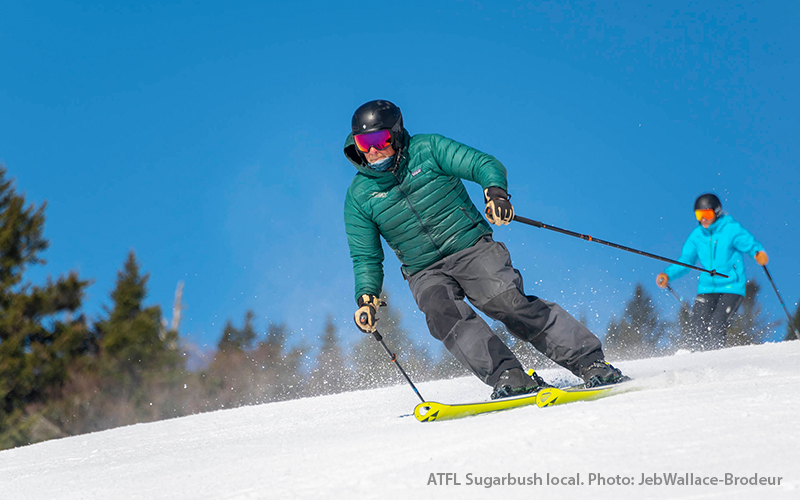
[344,128,507,299]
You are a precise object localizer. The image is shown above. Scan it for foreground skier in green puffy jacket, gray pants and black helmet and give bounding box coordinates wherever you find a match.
[344,100,623,399]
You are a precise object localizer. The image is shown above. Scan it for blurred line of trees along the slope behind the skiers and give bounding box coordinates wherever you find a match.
[0,164,800,449]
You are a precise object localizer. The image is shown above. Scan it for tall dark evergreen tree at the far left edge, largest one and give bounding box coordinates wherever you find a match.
[0,164,92,448]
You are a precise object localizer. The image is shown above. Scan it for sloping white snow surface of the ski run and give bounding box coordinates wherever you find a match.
[0,342,800,500]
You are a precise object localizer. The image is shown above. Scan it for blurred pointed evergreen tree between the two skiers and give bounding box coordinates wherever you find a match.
[603,283,666,359]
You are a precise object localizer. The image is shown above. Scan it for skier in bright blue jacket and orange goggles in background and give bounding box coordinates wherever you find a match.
[656,193,769,349]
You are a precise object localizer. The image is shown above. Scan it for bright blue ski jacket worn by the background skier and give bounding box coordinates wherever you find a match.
[664,214,764,296]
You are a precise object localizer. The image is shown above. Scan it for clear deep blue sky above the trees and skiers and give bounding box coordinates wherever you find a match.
[0,1,800,360]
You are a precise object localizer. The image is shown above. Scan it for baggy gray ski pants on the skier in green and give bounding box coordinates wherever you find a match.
[408,236,603,386]
